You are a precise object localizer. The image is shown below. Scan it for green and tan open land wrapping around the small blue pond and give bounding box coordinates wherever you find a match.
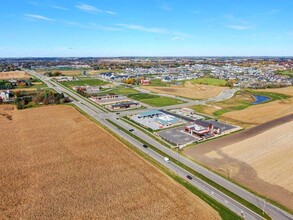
[191,87,293,128]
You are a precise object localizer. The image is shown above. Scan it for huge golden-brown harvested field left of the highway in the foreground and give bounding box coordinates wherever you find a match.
[0,105,220,219]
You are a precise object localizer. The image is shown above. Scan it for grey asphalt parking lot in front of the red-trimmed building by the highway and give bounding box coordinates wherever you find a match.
[157,126,199,146]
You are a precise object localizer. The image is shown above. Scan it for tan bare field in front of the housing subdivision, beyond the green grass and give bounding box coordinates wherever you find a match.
[142,81,227,99]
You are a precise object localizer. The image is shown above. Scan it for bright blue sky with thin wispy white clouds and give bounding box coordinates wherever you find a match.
[0,0,293,57]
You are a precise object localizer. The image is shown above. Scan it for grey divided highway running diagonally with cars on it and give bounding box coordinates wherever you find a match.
[27,71,293,220]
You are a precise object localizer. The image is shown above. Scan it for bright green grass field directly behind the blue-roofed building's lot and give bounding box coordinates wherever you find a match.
[128,93,184,107]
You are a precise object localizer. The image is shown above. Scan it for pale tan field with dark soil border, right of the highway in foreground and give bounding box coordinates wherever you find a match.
[184,114,293,210]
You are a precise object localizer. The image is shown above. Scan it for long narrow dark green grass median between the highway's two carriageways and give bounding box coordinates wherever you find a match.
[106,119,271,219]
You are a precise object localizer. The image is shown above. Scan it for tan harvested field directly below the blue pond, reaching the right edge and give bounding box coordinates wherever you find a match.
[221,98,293,125]
